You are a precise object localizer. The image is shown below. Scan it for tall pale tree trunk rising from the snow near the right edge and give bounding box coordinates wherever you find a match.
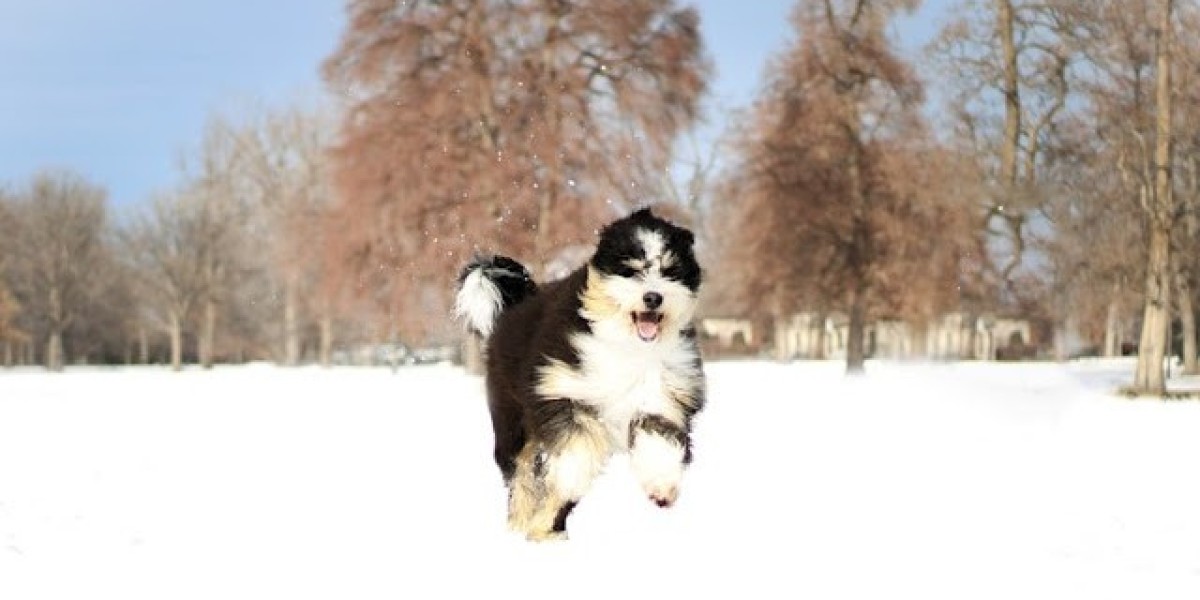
[1133,0,1175,396]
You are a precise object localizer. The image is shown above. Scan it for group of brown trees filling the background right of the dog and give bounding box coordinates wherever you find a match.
[719,0,1200,394]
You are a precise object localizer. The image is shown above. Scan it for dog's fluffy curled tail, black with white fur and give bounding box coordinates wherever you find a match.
[454,256,538,338]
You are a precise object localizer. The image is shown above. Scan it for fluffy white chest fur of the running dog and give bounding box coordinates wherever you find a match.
[538,334,701,449]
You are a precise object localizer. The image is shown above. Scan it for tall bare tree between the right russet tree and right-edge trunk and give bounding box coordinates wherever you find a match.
[931,0,1090,305]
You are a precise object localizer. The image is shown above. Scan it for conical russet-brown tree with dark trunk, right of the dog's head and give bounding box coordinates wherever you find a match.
[705,0,966,373]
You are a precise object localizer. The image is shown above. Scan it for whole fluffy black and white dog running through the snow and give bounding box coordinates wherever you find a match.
[455,209,704,540]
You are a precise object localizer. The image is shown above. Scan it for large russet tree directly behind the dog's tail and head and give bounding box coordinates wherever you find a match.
[324,0,709,345]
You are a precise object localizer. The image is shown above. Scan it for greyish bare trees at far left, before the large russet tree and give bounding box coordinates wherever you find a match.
[0,107,348,370]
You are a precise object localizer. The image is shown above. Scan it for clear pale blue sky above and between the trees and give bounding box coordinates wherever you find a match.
[0,0,949,211]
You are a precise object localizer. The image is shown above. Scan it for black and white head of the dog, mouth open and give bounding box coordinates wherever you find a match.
[583,209,701,343]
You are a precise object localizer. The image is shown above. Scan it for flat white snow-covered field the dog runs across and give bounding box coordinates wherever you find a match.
[0,361,1200,600]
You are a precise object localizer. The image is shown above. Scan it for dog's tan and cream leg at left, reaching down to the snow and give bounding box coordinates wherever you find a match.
[509,401,612,540]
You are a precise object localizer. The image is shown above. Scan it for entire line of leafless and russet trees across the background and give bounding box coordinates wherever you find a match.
[0,0,1200,392]
